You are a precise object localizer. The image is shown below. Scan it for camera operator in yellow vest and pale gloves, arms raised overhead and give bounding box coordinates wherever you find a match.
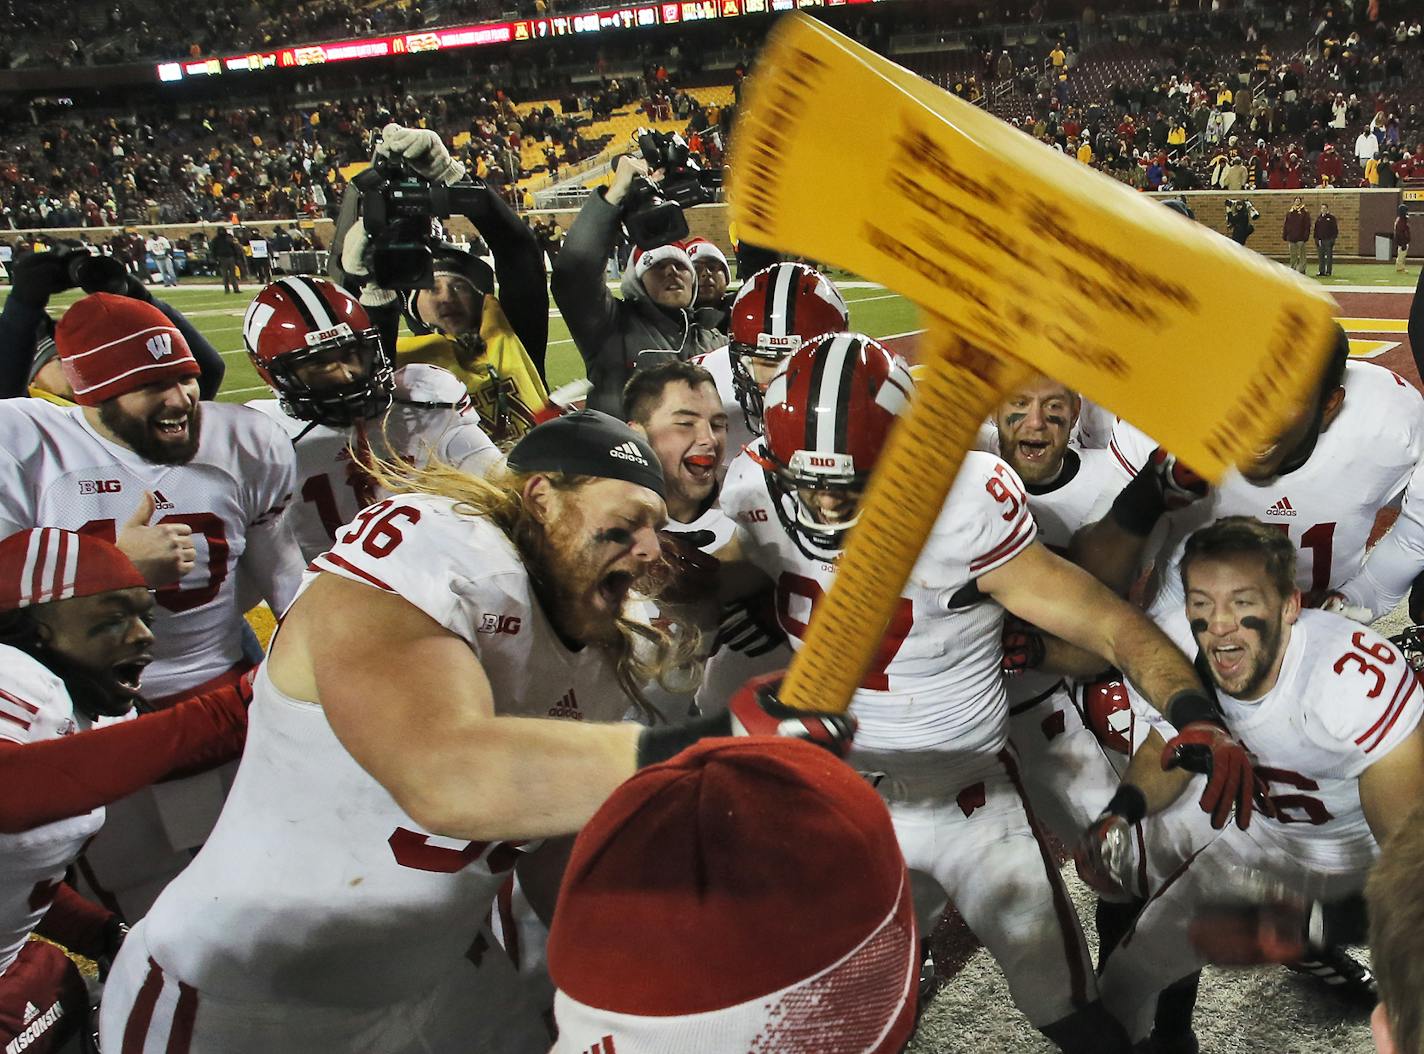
[332,124,548,440]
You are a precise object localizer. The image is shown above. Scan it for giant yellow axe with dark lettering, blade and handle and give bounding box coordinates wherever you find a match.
[731,14,1334,712]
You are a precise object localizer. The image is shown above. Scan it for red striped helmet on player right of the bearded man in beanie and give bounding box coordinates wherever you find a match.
[242,275,393,429]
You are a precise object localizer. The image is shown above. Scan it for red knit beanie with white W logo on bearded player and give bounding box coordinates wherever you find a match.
[54,293,199,406]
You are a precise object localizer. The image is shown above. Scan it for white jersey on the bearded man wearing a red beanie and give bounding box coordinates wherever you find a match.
[0,399,300,699]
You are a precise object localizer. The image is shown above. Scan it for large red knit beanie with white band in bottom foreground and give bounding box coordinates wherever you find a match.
[548,738,918,1054]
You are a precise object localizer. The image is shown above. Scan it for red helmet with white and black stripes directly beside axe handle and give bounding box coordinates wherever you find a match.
[753,333,914,560]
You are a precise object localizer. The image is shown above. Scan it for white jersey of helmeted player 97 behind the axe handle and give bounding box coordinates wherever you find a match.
[722,452,1037,755]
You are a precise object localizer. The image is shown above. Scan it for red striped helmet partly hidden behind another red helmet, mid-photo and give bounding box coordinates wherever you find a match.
[731,264,850,436]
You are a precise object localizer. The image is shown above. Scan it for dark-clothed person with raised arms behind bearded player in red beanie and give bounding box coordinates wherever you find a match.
[0,248,226,399]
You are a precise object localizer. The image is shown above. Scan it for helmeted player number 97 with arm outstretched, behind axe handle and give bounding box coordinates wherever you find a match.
[719,333,1246,1051]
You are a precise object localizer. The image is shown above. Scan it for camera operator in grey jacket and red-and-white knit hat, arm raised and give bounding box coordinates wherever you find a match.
[550,157,726,414]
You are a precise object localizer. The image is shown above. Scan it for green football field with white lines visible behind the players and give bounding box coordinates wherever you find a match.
[0,264,1418,402]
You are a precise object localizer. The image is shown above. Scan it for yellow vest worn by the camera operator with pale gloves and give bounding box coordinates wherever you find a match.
[396,295,557,443]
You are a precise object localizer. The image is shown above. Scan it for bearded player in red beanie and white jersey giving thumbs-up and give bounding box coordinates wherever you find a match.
[0,293,303,922]
